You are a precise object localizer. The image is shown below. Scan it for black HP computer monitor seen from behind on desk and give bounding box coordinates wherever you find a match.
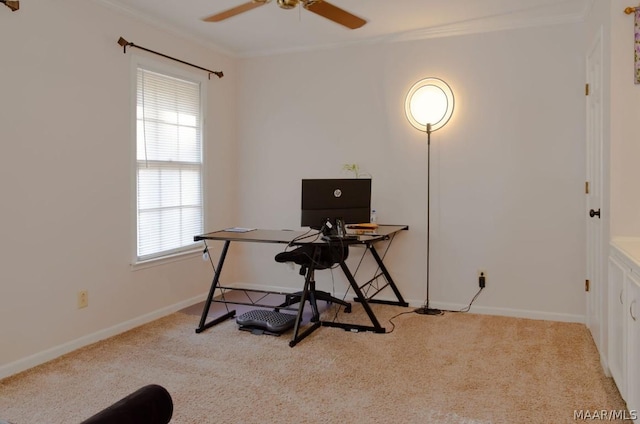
[301,178,371,230]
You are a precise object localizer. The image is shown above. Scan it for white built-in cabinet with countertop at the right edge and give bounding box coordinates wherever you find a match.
[607,238,640,423]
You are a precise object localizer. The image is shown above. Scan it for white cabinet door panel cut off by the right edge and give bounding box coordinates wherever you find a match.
[625,271,640,422]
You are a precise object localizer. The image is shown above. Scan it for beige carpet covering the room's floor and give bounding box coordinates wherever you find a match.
[0,304,624,424]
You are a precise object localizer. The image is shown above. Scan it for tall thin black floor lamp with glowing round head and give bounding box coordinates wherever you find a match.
[404,78,454,315]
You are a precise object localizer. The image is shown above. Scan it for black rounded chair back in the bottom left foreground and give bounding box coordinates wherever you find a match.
[81,384,173,424]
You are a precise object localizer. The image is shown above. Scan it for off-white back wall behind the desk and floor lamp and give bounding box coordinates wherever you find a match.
[238,24,585,321]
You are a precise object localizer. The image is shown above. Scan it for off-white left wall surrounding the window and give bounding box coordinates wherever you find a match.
[0,0,236,377]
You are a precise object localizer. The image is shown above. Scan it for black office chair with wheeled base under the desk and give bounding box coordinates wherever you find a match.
[275,244,351,322]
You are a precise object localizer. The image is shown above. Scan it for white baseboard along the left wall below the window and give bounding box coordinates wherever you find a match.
[0,294,207,379]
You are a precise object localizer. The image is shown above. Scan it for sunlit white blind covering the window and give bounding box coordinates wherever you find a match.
[136,67,204,261]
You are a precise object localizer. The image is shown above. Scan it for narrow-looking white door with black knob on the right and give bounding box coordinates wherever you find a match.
[584,31,607,352]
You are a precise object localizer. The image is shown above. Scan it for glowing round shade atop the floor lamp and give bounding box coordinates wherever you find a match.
[404,78,454,132]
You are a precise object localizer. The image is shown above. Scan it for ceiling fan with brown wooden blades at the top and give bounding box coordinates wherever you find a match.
[202,0,367,29]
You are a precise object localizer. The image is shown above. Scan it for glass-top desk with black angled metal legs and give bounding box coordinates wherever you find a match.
[194,225,409,347]
